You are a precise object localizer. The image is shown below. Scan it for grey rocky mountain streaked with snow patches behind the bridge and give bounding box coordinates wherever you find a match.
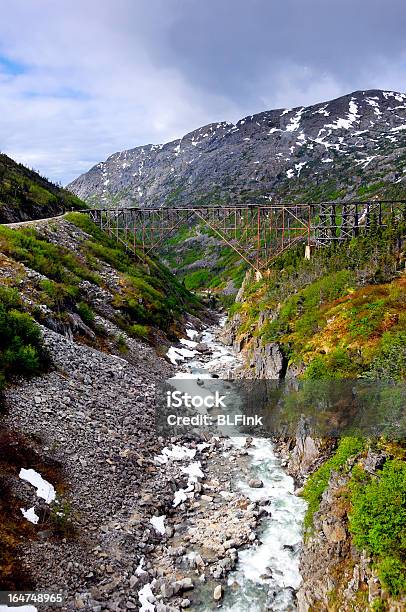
[68,90,406,207]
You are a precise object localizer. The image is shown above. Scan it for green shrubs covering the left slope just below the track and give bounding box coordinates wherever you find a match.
[0,213,199,344]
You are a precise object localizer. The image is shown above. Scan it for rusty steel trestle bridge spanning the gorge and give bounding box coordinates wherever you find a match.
[81,199,406,273]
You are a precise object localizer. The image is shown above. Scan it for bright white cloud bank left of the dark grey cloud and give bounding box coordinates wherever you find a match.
[0,0,243,182]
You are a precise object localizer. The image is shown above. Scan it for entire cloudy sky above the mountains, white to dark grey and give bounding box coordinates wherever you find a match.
[0,0,406,184]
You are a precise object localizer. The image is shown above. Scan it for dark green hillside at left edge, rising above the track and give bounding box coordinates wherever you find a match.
[0,153,86,223]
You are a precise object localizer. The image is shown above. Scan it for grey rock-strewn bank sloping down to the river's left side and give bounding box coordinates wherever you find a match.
[3,310,272,612]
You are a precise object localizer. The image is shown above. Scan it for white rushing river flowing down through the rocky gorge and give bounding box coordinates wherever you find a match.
[167,319,306,612]
